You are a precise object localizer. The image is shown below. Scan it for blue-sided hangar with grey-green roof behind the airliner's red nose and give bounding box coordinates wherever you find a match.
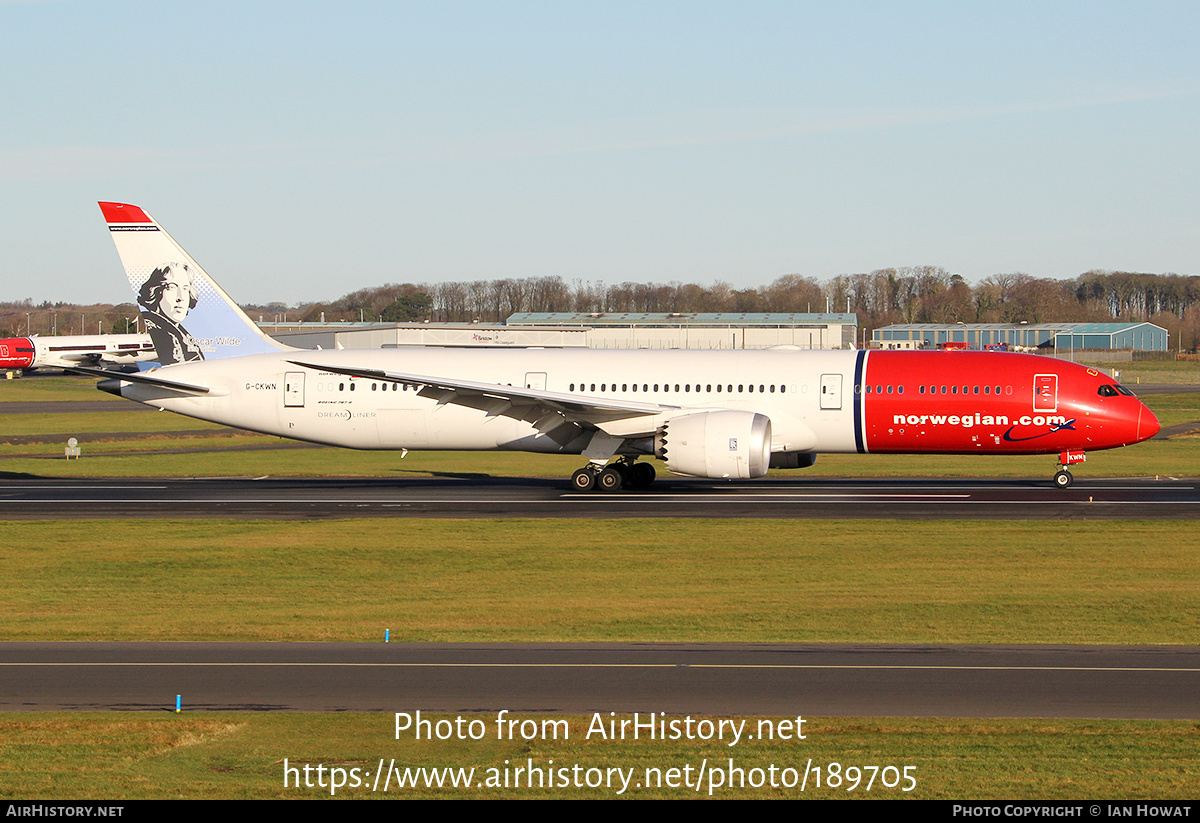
[871,323,1169,360]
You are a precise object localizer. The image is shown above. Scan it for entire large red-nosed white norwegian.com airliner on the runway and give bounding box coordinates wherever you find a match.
[68,203,1159,491]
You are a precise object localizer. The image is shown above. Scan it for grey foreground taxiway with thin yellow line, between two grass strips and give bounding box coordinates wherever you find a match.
[0,643,1200,719]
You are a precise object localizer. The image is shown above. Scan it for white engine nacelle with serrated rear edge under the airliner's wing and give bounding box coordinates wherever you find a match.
[654,412,770,480]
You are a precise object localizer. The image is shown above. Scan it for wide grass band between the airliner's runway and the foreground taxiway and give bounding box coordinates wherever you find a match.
[0,519,1200,644]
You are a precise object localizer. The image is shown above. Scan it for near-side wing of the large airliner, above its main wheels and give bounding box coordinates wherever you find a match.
[288,360,680,431]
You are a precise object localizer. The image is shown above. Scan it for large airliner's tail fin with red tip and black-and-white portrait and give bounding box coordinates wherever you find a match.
[100,203,292,366]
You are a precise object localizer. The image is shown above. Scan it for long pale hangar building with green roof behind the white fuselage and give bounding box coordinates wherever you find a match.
[270,312,858,349]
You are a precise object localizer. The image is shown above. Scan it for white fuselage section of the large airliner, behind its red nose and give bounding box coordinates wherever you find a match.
[112,348,859,453]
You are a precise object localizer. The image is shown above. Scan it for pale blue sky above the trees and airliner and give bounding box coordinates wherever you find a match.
[0,0,1200,302]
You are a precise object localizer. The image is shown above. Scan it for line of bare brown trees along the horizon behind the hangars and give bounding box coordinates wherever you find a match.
[7,266,1200,352]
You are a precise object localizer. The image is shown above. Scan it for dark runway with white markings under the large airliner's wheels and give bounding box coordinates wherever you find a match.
[0,475,1200,519]
